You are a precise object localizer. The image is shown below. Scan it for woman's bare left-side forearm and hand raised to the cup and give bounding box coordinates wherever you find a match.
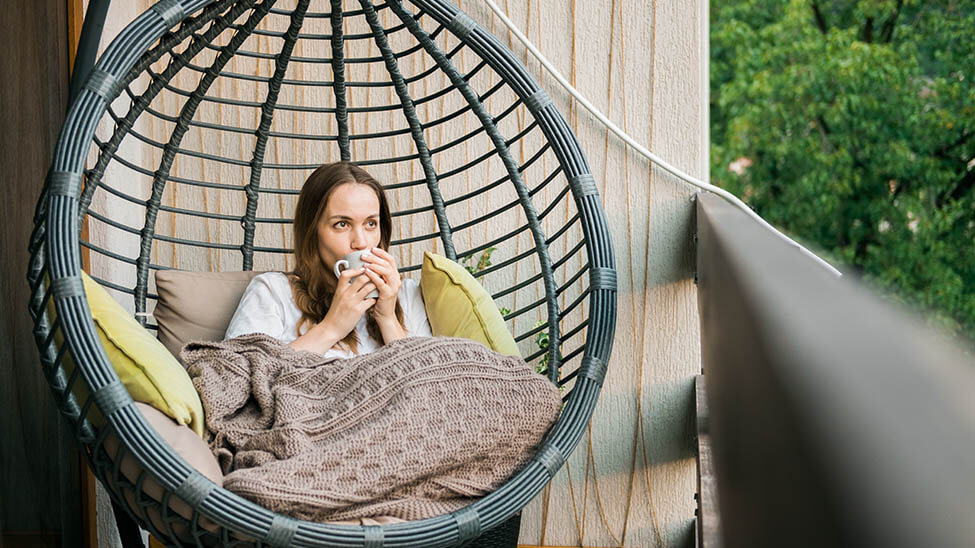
[291,268,376,353]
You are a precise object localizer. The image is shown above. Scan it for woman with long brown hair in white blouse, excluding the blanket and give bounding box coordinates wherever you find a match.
[226,162,431,358]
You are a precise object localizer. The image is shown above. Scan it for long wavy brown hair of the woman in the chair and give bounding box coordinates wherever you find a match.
[288,162,405,353]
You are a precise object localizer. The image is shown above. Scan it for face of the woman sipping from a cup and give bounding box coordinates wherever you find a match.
[318,183,382,270]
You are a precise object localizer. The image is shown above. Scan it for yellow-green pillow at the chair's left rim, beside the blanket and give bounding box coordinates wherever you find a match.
[82,273,203,436]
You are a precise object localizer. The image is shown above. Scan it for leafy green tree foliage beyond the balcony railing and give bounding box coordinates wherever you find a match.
[710,0,975,338]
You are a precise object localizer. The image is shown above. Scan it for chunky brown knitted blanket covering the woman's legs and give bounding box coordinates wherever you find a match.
[181,335,561,521]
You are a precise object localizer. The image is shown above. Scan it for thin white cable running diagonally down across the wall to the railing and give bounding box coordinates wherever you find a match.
[484,0,842,276]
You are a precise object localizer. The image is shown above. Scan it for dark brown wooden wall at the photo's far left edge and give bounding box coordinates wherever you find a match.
[0,0,83,547]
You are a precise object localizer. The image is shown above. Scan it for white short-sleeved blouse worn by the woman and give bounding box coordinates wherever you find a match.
[225,272,433,358]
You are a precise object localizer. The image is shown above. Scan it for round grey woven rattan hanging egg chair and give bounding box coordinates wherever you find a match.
[28,0,616,547]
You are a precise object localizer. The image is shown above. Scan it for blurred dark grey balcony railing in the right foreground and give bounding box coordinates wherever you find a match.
[697,194,975,548]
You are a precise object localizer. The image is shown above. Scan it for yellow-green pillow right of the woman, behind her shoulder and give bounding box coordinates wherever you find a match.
[420,252,521,357]
